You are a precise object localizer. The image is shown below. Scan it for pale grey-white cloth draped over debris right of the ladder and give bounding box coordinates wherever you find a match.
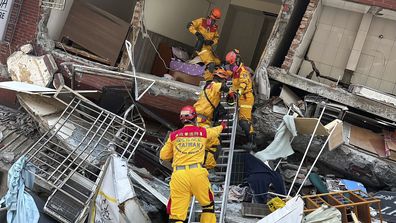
[254,115,297,162]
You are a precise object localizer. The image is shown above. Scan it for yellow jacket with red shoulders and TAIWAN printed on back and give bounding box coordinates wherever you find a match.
[160,125,223,167]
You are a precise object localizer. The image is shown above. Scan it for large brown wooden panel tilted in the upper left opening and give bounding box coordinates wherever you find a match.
[61,0,129,65]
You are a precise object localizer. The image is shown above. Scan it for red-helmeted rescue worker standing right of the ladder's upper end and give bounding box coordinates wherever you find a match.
[226,49,256,150]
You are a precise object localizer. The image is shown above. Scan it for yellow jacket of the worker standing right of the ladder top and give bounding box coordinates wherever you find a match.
[232,63,253,95]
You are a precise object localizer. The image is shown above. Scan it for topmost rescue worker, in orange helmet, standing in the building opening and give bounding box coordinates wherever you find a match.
[187,8,221,80]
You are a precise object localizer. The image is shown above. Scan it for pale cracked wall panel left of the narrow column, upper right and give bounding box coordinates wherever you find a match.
[299,6,363,83]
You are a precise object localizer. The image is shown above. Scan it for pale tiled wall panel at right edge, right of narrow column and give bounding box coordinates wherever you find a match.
[352,17,396,94]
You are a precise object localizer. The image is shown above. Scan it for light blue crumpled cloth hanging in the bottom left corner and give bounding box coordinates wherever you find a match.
[0,156,40,223]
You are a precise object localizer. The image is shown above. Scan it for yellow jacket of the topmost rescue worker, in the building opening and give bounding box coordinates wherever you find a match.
[188,18,219,45]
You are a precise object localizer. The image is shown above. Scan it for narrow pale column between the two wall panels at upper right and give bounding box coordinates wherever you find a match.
[346,13,373,71]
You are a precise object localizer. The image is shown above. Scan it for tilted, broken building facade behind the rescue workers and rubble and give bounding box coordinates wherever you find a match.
[0,0,396,222]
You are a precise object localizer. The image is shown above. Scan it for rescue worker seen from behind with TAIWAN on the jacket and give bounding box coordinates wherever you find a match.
[160,106,226,223]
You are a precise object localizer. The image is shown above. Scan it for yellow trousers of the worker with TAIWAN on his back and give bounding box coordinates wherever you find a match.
[167,167,216,223]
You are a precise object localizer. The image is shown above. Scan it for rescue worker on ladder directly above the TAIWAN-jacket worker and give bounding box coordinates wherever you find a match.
[194,68,229,169]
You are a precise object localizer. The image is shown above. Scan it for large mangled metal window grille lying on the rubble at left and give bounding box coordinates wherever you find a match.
[25,87,145,222]
